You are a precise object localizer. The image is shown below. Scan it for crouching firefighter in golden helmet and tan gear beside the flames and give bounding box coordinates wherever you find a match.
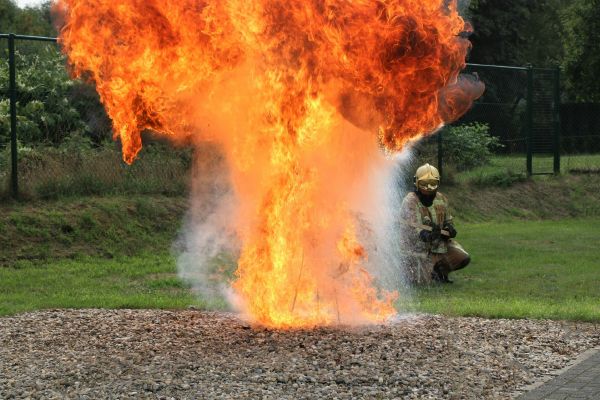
[401,164,471,283]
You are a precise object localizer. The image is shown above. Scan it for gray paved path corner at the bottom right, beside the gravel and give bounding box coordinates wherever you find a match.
[518,349,600,400]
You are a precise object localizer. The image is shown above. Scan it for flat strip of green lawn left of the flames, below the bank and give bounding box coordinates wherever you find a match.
[0,253,224,315]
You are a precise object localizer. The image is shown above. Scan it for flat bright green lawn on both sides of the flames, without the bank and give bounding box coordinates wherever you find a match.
[0,219,600,321]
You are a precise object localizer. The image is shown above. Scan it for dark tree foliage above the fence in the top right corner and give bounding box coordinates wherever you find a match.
[465,0,600,102]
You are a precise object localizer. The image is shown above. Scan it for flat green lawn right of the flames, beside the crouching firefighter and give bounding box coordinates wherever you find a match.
[400,218,600,321]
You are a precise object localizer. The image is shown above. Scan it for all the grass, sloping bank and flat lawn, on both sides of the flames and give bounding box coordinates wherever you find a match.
[0,175,600,320]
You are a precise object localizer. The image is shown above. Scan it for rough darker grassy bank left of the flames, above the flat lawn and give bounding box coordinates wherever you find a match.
[0,196,187,266]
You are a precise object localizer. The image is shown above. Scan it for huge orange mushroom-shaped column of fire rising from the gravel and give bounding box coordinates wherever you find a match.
[55,0,483,328]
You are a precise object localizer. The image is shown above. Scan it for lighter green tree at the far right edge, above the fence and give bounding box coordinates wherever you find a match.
[561,0,600,102]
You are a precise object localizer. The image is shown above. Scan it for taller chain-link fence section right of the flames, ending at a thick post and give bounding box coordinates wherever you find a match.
[441,64,560,175]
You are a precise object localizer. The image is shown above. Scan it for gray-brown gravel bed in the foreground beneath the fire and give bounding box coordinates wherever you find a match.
[0,310,600,399]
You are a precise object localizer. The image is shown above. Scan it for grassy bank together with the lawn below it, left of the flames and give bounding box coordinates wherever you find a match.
[0,196,205,315]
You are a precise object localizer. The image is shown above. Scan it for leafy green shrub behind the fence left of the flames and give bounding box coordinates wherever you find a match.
[0,46,111,145]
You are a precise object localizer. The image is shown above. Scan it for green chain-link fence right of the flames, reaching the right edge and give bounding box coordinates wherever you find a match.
[436,64,600,179]
